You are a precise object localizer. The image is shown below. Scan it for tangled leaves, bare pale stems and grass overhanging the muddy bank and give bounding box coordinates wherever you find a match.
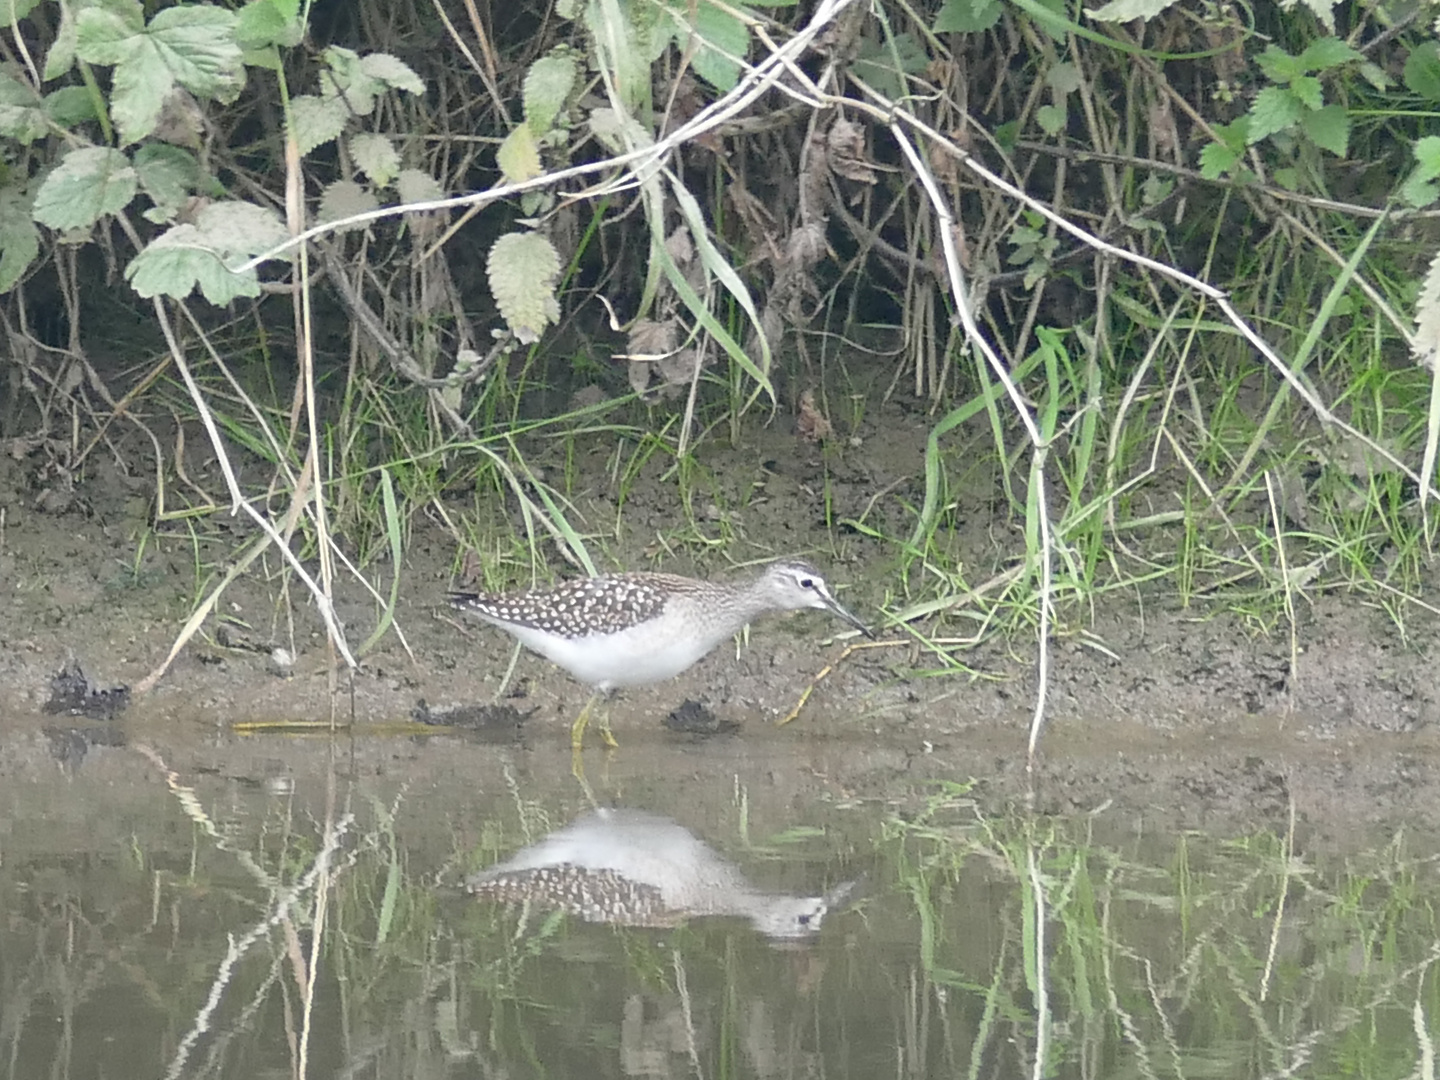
[0,0,1440,743]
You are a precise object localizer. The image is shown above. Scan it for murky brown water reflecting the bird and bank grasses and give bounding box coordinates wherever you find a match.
[0,710,1440,1080]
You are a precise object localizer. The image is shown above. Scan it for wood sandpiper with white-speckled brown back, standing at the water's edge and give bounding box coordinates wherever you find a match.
[451,559,874,749]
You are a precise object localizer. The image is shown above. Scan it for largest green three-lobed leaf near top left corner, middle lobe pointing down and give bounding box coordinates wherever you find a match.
[75,4,245,143]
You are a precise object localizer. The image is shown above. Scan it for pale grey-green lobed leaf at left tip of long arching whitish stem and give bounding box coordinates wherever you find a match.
[125,202,288,307]
